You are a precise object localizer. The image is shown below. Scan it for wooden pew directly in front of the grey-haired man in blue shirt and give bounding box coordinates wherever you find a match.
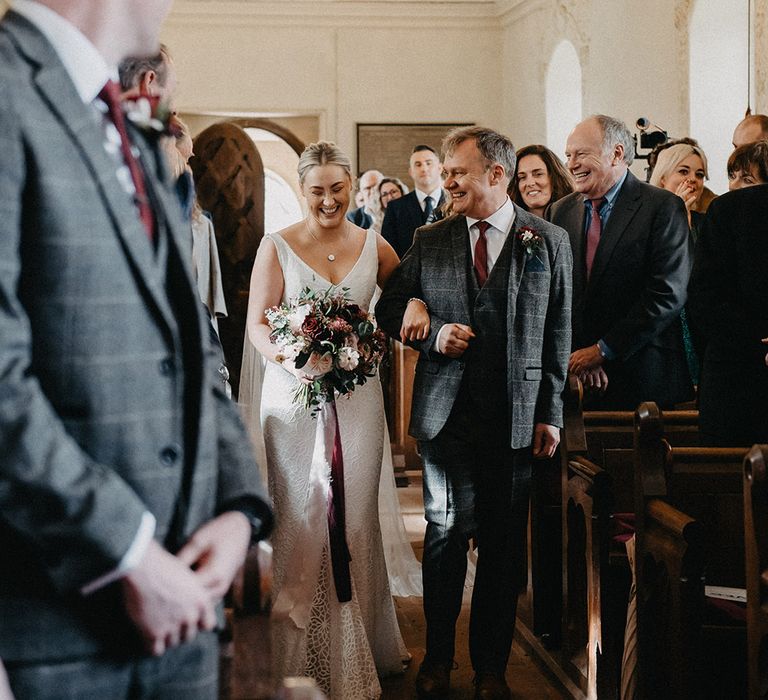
[561,377,698,698]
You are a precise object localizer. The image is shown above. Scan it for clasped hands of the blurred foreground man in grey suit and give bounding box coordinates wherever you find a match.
[122,511,251,656]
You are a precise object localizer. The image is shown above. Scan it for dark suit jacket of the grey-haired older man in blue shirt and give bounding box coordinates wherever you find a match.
[549,173,693,410]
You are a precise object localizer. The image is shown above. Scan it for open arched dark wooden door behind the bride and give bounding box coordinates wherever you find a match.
[190,123,264,394]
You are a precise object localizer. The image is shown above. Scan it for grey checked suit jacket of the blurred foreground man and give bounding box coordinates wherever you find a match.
[0,12,266,661]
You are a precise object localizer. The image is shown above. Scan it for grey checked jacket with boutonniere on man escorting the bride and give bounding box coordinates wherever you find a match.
[376,206,571,448]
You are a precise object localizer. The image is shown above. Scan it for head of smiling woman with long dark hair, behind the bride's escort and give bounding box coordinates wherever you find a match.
[509,144,573,218]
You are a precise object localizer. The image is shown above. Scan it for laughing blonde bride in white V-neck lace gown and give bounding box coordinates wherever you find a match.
[240,142,429,700]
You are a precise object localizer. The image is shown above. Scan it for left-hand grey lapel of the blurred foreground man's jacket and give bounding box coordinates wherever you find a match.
[12,15,178,334]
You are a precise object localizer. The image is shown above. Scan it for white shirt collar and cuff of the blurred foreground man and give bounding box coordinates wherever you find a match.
[11,0,156,595]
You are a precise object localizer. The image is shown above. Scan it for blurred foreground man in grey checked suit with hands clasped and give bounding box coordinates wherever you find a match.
[0,0,271,700]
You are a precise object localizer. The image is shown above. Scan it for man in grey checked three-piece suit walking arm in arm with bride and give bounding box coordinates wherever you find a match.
[376,127,571,700]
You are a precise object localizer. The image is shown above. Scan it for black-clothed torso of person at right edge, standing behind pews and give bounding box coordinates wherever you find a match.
[688,185,768,447]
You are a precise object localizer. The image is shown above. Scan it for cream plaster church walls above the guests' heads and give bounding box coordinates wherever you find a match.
[0,0,768,179]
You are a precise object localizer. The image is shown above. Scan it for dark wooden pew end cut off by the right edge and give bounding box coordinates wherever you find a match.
[744,445,768,700]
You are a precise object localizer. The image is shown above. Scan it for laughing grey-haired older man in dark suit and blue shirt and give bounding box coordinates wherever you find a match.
[550,115,693,410]
